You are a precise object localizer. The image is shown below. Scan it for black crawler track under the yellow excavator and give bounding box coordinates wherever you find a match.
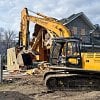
[44,67,100,90]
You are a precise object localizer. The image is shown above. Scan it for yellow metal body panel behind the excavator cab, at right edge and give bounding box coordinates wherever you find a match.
[82,53,100,71]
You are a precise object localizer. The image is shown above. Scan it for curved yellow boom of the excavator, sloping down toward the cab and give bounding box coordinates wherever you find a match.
[28,16,70,37]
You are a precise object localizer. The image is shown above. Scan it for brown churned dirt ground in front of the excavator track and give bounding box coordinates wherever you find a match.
[0,75,100,100]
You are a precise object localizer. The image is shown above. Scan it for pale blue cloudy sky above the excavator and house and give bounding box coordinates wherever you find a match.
[0,0,100,31]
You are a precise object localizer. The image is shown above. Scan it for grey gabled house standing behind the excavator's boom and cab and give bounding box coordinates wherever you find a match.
[60,12,100,43]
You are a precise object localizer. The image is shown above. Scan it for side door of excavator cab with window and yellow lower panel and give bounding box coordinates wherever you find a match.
[66,39,81,68]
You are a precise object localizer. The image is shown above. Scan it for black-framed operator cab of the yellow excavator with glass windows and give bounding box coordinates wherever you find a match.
[50,38,82,68]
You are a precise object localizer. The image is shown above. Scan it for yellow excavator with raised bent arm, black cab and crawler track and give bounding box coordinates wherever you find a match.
[7,8,100,89]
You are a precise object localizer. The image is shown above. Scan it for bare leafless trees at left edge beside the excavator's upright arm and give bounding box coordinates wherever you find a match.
[0,28,16,65]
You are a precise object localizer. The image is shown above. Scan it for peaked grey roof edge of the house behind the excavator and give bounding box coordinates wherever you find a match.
[60,12,95,29]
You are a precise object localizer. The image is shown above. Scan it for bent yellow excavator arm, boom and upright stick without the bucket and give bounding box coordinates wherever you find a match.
[19,8,70,49]
